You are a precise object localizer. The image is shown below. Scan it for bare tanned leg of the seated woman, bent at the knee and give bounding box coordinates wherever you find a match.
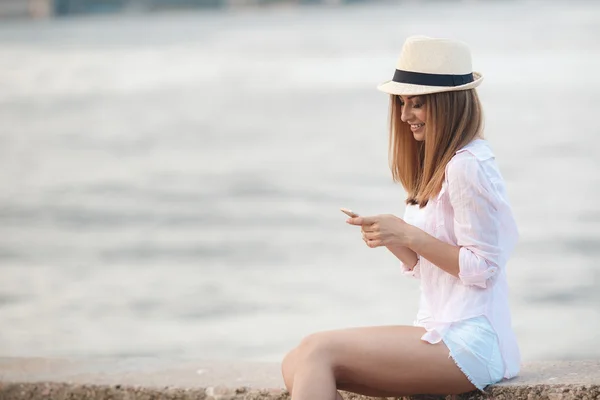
[282,326,475,400]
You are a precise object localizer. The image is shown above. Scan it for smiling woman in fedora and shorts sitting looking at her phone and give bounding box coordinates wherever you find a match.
[282,37,520,400]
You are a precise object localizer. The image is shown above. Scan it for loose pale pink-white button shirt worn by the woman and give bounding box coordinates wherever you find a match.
[401,139,521,378]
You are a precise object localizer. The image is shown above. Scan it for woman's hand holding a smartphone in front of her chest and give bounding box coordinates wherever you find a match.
[346,214,413,248]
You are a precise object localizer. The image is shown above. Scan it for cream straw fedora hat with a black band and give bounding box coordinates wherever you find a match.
[377,36,483,96]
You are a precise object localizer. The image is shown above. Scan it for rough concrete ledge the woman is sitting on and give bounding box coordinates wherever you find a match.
[0,358,600,400]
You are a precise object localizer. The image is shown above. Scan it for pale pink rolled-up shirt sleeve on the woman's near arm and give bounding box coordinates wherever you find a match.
[446,154,502,288]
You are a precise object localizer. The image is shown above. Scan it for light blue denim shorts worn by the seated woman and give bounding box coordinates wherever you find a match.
[442,316,504,391]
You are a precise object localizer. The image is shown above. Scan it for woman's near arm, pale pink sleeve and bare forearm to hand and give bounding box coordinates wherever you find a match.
[348,156,508,288]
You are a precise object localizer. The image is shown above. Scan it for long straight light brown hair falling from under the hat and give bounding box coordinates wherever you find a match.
[389,89,483,208]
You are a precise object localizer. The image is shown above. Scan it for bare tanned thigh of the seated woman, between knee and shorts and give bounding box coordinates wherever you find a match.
[304,326,475,397]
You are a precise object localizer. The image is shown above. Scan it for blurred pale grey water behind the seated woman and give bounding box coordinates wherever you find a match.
[0,1,600,361]
